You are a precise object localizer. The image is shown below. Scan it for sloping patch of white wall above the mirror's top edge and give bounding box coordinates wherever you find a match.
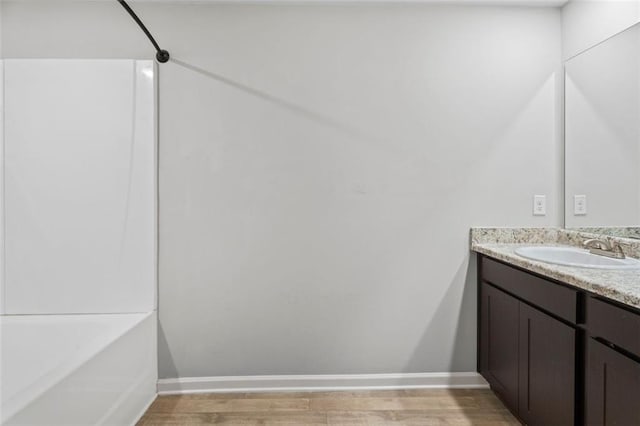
[562,0,640,59]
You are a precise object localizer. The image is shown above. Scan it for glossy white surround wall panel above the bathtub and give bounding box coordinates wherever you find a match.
[4,60,156,314]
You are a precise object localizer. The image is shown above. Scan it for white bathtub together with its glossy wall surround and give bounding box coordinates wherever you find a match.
[0,59,157,426]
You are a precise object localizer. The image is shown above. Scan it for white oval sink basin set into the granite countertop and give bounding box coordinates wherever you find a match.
[515,246,640,269]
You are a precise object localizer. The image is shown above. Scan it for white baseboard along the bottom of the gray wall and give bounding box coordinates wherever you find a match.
[158,372,489,395]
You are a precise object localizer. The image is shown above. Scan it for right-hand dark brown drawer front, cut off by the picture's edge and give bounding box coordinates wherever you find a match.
[587,296,640,356]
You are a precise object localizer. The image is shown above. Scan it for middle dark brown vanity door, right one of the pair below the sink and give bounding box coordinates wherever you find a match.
[518,303,576,426]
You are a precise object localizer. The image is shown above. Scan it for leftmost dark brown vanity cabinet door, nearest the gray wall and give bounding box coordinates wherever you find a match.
[480,283,520,412]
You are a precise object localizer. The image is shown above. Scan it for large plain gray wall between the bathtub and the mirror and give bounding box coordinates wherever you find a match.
[3,1,562,378]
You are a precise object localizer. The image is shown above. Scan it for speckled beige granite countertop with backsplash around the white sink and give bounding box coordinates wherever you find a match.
[471,228,640,309]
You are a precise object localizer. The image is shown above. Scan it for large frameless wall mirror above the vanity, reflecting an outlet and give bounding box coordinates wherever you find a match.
[565,24,640,238]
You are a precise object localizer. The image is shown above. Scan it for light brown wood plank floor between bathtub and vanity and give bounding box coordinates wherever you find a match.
[138,389,520,426]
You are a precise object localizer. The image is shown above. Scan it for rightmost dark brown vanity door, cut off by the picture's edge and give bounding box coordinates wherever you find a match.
[586,339,640,426]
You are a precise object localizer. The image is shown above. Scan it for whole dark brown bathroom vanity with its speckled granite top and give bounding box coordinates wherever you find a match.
[472,230,640,425]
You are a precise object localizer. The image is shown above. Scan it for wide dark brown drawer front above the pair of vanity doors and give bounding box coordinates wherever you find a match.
[481,256,578,323]
